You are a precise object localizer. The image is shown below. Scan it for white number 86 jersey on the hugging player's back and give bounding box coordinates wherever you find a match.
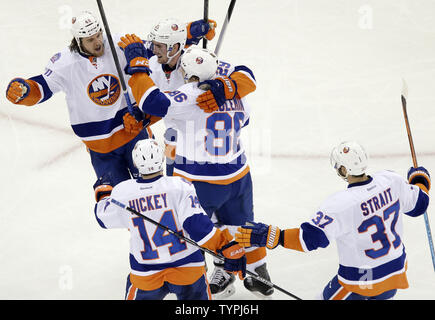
[165,83,250,184]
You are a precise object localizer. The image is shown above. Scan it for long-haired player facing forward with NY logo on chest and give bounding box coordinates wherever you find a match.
[6,11,217,188]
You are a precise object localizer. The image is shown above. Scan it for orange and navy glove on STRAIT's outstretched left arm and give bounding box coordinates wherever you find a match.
[235,222,281,249]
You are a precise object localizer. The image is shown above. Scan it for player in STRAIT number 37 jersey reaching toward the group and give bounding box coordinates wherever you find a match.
[236,141,431,300]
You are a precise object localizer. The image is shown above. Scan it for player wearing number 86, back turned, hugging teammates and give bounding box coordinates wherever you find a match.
[116,40,273,296]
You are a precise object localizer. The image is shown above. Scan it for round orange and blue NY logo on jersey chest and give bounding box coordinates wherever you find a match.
[88,74,121,107]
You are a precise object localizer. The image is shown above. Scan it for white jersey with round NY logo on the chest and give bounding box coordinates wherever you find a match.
[34,36,151,153]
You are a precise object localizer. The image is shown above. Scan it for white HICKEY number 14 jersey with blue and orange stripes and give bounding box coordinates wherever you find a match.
[95,176,231,290]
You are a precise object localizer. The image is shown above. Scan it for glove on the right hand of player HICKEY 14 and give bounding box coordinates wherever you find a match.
[217,241,246,280]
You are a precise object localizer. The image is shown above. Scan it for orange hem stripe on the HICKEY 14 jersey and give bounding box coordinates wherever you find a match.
[130,266,206,290]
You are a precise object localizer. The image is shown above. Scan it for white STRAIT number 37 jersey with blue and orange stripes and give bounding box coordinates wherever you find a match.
[284,171,428,296]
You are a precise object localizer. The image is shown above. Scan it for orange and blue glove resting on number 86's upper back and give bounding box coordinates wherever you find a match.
[196,76,237,112]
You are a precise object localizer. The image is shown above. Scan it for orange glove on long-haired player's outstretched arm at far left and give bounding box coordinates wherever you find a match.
[6,78,41,106]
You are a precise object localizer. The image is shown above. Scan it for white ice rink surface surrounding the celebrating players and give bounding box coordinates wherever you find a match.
[0,0,435,300]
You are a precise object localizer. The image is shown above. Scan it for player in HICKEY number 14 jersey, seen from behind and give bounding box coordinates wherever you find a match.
[95,139,246,300]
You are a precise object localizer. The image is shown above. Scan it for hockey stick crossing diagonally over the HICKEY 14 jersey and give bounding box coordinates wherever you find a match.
[110,198,302,300]
